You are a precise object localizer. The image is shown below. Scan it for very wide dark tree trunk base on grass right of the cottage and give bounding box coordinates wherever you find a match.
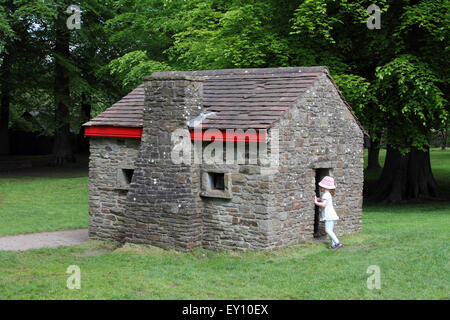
[370,147,438,203]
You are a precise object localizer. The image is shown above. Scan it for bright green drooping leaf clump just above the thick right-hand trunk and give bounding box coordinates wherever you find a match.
[376,54,448,152]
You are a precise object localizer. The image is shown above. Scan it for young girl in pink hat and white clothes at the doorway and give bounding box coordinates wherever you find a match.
[314,176,342,249]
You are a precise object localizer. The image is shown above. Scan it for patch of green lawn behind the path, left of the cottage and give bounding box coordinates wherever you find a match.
[0,159,89,236]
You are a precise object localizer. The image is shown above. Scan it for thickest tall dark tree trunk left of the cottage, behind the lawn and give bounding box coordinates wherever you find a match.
[53,16,75,164]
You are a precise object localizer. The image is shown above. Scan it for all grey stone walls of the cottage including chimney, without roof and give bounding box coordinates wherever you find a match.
[90,74,363,250]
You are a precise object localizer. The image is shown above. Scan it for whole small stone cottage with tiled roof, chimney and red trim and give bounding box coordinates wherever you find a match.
[84,67,365,250]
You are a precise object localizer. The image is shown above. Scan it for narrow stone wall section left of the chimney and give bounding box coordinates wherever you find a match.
[89,137,140,241]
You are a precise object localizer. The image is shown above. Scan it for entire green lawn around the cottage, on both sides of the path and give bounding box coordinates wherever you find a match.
[0,149,450,299]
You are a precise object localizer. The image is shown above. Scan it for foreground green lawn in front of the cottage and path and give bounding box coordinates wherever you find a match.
[0,204,450,299]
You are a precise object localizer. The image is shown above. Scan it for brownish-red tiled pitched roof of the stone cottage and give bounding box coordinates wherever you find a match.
[85,67,364,131]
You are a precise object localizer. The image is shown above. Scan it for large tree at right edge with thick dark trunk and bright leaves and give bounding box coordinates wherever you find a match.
[373,1,449,202]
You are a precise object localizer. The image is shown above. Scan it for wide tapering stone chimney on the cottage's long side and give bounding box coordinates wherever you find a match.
[124,75,203,250]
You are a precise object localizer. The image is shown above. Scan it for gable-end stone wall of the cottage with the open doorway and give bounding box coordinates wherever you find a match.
[267,74,364,247]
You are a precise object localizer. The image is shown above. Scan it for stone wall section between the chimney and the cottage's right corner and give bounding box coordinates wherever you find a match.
[202,164,271,250]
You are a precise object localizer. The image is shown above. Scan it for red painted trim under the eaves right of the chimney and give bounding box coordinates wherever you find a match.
[191,129,267,142]
